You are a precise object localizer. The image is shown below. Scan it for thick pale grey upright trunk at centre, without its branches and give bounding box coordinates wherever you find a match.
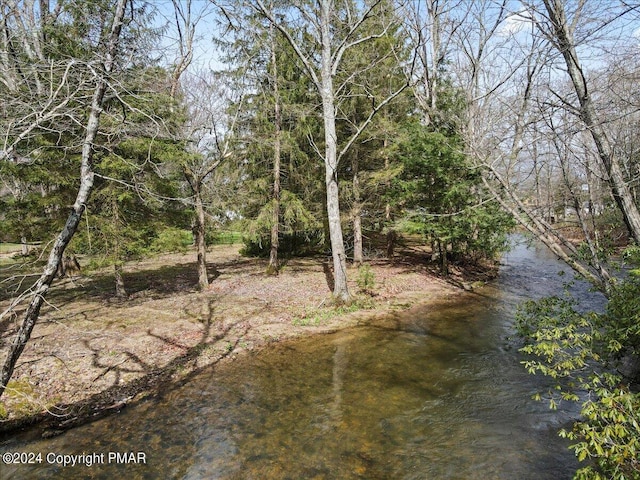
[320,0,351,303]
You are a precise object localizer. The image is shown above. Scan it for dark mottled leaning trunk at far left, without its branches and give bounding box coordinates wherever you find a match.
[0,0,127,397]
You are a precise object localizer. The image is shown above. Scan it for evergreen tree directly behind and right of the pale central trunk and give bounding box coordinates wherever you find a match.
[337,10,415,265]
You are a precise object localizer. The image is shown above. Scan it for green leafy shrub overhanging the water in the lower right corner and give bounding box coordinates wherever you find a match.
[517,276,640,480]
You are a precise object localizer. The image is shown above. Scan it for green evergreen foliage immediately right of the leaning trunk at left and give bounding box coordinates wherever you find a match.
[64,66,192,290]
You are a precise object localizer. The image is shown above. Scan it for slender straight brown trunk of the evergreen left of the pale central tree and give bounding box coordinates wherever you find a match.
[267,25,282,274]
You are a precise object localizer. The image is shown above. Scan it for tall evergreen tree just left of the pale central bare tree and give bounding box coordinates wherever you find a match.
[225,4,324,262]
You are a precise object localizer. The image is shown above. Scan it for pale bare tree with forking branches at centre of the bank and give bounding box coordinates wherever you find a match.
[256,0,405,303]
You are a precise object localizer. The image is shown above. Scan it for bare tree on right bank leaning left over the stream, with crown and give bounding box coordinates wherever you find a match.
[444,2,609,291]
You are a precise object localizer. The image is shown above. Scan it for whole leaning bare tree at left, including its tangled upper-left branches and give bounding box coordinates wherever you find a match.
[0,0,134,402]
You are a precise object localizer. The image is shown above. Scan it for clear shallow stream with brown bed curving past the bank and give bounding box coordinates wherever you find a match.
[0,238,598,480]
